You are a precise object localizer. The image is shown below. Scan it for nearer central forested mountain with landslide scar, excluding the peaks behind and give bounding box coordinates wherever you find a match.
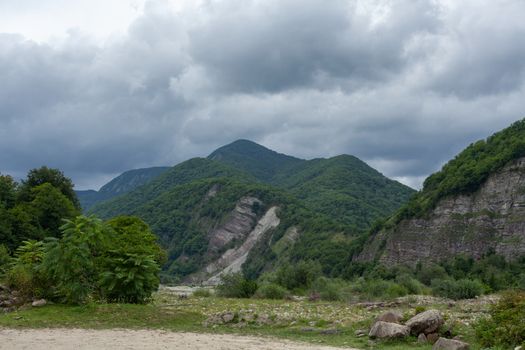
[90,158,354,283]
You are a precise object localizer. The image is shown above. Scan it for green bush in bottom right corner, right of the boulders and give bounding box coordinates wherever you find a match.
[474,291,525,349]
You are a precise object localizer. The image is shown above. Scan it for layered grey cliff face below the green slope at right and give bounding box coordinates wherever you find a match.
[357,158,525,265]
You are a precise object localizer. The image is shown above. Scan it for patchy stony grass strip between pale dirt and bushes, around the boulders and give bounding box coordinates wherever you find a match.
[0,292,494,350]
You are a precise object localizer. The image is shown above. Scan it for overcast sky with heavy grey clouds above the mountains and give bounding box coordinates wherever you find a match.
[0,0,525,189]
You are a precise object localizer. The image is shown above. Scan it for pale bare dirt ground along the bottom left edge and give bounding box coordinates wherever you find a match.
[0,329,350,350]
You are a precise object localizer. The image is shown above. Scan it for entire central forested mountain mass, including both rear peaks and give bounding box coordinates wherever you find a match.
[88,140,413,284]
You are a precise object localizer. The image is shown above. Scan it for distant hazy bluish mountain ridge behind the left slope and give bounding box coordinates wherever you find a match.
[75,167,169,210]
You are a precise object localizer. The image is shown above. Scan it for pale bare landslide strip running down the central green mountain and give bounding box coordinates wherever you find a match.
[206,207,280,285]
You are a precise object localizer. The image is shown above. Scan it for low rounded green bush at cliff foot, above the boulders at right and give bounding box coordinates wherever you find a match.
[432,278,485,300]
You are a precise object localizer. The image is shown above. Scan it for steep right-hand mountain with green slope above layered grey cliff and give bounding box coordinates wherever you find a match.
[356,119,525,266]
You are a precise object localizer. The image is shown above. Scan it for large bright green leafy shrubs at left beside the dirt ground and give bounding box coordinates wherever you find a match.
[42,216,162,304]
